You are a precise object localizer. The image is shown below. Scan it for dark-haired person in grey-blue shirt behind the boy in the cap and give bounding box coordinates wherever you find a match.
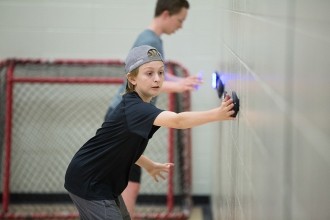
[105,0,202,216]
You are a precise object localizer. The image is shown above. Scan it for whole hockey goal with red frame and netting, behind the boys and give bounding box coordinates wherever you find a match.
[0,59,192,219]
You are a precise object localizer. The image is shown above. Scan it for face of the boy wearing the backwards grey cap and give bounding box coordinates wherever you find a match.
[131,61,164,102]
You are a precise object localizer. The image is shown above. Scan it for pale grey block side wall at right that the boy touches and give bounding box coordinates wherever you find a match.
[213,0,330,220]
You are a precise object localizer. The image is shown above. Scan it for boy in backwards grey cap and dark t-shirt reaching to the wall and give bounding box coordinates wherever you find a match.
[64,45,234,220]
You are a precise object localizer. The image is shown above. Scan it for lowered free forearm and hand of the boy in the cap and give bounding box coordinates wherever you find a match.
[135,155,174,182]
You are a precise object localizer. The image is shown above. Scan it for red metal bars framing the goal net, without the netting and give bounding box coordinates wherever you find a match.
[0,59,192,219]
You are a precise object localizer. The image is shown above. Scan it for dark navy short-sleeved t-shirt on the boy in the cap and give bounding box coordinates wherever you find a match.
[64,92,163,200]
